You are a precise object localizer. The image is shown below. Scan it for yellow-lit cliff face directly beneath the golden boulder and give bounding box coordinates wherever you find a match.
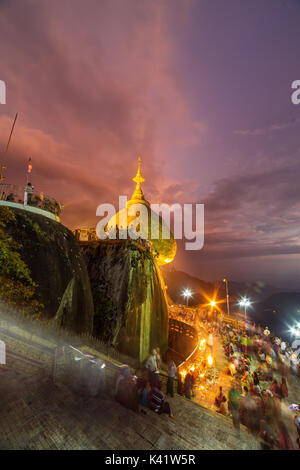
[81,240,168,361]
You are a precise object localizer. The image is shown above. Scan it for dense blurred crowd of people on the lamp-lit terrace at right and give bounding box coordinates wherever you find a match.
[215,322,300,450]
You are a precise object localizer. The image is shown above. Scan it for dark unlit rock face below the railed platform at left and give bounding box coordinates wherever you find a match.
[5,209,94,333]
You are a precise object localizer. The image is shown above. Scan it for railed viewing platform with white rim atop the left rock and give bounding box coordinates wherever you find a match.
[0,183,62,222]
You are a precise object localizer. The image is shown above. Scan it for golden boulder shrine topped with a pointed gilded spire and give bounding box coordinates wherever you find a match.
[106,157,177,265]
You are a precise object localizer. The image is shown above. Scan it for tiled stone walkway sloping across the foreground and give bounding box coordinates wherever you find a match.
[0,368,259,450]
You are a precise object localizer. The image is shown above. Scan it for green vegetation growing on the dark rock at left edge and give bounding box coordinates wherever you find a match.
[0,207,43,315]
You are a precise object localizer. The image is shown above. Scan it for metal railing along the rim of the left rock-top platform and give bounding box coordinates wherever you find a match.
[0,183,62,216]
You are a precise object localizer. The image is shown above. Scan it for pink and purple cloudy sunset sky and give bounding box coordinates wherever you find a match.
[0,0,300,288]
